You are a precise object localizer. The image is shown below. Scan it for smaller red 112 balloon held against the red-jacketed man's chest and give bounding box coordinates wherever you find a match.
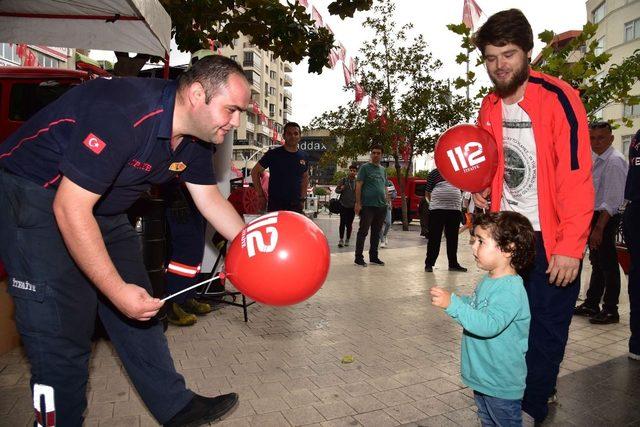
[434,124,498,193]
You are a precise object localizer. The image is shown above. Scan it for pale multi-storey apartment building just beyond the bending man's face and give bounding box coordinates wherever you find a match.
[220,35,293,148]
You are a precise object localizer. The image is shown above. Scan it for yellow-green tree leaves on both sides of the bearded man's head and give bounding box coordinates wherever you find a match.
[447,22,640,126]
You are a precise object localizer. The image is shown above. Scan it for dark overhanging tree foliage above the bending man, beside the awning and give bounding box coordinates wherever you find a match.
[114,0,373,75]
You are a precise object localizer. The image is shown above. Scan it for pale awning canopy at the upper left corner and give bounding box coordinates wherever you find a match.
[0,0,171,58]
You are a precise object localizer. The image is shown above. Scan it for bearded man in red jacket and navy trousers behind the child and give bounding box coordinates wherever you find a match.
[473,9,594,422]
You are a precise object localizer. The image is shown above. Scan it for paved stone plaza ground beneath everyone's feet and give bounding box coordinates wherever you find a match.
[0,215,640,427]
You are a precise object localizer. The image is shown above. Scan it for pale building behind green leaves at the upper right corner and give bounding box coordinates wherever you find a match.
[586,0,640,156]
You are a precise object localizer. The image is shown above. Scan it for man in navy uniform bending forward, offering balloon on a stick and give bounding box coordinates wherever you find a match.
[0,56,250,427]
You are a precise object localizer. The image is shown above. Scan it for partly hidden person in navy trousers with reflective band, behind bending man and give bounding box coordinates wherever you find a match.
[164,179,211,326]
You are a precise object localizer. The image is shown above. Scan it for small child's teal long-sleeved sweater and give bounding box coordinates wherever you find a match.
[446,275,531,399]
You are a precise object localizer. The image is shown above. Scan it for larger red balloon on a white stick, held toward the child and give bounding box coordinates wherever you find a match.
[225,211,330,305]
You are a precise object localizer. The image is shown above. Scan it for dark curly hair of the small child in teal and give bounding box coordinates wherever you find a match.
[473,212,535,274]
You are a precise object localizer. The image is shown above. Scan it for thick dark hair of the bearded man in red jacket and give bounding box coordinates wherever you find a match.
[472,9,533,55]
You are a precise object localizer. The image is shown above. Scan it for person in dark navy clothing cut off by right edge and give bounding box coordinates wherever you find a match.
[622,130,640,361]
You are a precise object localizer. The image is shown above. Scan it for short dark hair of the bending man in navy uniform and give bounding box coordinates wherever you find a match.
[178,55,246,104]
